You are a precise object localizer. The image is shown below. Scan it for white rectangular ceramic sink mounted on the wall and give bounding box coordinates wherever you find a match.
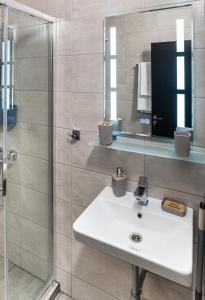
[73,187,193,286]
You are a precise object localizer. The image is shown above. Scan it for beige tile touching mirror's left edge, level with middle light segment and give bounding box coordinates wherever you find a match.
[72,54,103,93]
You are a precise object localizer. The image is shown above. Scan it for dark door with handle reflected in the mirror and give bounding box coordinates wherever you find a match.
[151,41,191,138]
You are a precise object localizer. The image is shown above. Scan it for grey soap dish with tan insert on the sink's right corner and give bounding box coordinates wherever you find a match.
[161,197,186,217]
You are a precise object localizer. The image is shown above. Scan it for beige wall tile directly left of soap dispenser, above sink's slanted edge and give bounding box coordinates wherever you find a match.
[72,168,111,207]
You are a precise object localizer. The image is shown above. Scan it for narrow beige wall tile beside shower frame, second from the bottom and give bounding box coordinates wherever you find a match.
[54,233,71,273]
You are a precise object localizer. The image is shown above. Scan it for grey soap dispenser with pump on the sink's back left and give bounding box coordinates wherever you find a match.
[112,167,127,197]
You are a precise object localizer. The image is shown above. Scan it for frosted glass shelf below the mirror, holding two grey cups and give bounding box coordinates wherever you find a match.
[89,137,205,164]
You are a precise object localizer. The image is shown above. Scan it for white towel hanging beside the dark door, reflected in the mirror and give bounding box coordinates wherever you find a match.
[137,62,152,112]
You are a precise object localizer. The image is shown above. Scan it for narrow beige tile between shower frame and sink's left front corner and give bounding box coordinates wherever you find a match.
[54,199,72,237]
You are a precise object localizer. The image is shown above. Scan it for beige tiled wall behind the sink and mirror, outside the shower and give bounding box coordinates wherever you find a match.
[18,0,205,300]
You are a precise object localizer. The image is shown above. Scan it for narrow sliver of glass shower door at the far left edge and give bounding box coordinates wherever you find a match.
[0,6,9,300]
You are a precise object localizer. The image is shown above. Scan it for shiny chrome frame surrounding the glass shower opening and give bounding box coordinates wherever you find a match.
[0,0,57,300]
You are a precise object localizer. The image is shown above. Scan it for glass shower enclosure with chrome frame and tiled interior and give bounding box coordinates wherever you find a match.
[0,0,55,300]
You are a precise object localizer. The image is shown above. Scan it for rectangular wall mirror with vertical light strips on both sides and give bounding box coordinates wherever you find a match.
[104,6,194,138]
